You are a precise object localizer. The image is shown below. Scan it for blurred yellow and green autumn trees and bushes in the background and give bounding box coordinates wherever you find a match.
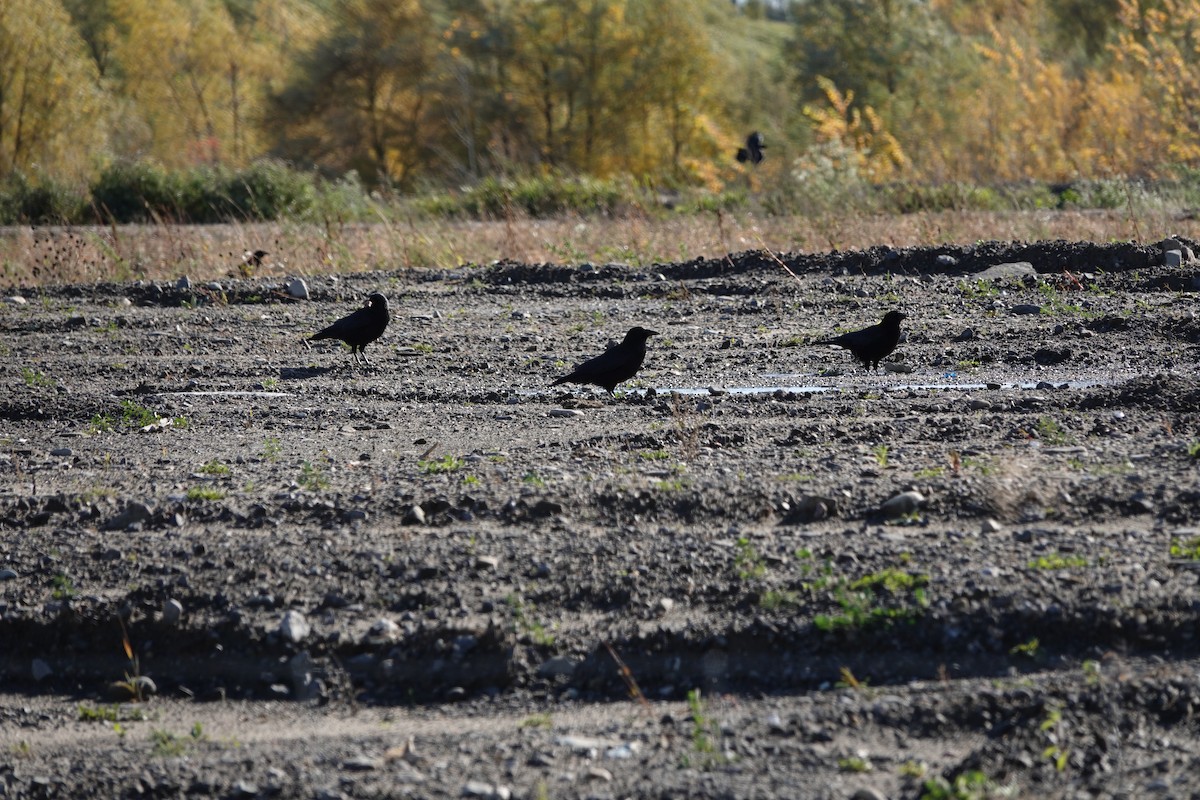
[0,0,1200,223]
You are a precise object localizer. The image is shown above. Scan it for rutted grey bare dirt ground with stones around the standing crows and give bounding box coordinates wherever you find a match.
[0,241,1200,798]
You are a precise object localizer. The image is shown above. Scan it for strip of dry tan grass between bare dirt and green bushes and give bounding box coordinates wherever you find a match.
[0,211,1200,285]
